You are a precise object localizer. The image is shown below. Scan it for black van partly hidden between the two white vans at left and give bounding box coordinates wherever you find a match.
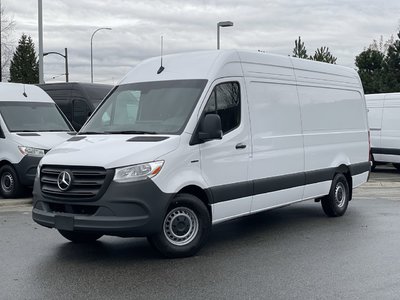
[38,82,113,131]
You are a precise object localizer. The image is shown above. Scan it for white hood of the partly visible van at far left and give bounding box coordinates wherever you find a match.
[10,131,71,150]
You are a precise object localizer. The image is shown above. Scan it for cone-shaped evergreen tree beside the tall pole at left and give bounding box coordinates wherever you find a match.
[10,34,39,84]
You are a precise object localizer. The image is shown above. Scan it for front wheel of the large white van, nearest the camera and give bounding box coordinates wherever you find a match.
[147,194,211,258]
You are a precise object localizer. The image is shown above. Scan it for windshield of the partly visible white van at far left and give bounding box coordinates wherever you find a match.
[0,101,73,132]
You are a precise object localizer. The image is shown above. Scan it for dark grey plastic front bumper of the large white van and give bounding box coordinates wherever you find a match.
[32,177,173,237]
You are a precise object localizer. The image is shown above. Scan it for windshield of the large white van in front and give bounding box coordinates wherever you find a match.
[80,80,207,134]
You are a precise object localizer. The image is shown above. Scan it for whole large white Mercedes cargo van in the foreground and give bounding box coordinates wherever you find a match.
[33,50,370,257]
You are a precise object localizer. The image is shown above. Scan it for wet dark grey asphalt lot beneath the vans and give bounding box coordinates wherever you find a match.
[0,167,400,299]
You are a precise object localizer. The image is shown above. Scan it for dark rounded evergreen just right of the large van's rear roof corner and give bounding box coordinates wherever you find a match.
[356,48,385,94]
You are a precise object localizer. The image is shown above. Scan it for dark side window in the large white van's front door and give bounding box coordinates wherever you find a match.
[204,82,240,134]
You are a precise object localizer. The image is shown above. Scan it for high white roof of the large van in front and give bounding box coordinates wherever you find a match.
[119,50,361,88]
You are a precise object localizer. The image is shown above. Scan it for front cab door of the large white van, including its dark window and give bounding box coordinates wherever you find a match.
[200,78,252,222]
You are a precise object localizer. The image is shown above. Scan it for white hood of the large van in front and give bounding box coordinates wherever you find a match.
[41,135,180,169]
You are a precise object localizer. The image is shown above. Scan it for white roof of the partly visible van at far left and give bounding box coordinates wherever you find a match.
[0,82,54,103]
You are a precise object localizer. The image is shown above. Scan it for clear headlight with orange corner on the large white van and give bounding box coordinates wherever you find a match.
[114,160,164,182]
